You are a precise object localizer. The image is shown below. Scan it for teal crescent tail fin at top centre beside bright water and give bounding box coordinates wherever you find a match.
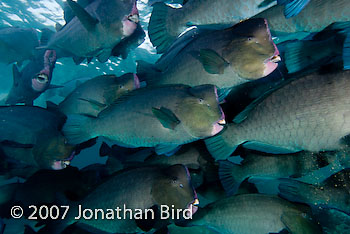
[148,2,178,54]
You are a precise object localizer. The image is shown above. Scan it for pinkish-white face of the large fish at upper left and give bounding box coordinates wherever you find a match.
[122,0,140,37]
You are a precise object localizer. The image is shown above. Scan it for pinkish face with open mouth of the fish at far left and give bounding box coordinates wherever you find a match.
[31,50,56,93]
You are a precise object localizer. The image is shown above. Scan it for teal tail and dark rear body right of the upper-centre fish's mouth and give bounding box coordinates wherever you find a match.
[284,37,342,73]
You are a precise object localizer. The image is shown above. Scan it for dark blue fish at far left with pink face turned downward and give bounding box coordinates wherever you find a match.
[6,50,56,105]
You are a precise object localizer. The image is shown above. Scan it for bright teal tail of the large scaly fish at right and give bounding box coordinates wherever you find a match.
[205,125,240,160]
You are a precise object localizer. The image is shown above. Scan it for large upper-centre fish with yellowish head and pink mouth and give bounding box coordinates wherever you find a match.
[138,19,279,89]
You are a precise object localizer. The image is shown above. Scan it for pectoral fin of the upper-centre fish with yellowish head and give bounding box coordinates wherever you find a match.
[198,49,229,74]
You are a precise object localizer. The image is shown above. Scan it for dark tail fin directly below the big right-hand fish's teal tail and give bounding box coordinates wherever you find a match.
[219,160,244,196]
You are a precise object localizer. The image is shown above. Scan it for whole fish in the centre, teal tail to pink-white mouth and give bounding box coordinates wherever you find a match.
[63,85,224,154]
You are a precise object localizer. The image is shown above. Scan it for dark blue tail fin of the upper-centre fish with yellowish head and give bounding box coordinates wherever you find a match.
[137,60,162,86]
